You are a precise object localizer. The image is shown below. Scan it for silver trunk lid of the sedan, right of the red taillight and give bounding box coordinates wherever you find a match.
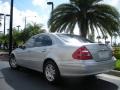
[85,43,112,62]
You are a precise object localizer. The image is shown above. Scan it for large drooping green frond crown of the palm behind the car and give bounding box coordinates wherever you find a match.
[48,0,120,38]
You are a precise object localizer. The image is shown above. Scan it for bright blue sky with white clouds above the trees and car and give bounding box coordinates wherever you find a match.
[0,0,120,43]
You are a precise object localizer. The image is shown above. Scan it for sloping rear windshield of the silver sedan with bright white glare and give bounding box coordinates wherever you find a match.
[57,34,94,44]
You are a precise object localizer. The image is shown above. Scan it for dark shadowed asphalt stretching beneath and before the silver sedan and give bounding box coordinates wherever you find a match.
[1,67,118,90]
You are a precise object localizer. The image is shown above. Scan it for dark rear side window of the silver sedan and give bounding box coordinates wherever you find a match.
[34,35,52,47]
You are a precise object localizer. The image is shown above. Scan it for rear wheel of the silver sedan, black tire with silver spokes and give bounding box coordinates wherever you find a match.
[43,61,61,84]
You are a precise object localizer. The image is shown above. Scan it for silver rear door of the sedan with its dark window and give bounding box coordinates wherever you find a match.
[26,35,52,71]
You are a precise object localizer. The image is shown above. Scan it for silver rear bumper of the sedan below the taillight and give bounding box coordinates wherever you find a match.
[59,60,115,76]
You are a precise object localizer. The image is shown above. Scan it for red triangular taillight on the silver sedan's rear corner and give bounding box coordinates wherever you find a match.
[72,46,92,60]
